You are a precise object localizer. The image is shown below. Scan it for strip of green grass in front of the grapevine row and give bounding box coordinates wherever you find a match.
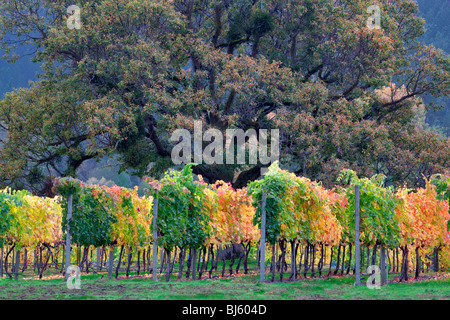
[0,274,450,300]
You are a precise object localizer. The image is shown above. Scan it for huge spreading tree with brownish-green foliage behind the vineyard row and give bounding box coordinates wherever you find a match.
[0,0,450,187]
